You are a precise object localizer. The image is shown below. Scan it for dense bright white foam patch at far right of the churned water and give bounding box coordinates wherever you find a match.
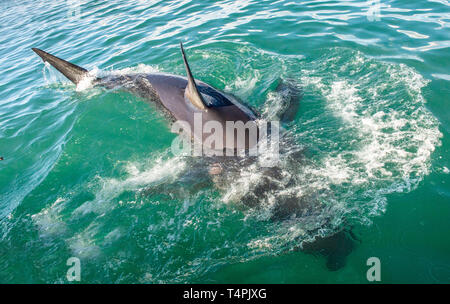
[308,61,442,203]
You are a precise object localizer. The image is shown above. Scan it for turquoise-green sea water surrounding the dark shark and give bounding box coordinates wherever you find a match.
[0,0,450,283]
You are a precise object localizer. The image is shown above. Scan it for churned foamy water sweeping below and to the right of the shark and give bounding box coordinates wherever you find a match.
[29,48,442,282]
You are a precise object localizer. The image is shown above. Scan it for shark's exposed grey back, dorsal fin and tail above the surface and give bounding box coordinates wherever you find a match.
[32,46,257,150]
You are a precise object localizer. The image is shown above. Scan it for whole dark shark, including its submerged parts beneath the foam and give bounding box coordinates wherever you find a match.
[32,43,356,270]
